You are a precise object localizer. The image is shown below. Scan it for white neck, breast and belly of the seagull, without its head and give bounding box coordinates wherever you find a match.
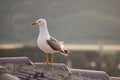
[37,23,55,53]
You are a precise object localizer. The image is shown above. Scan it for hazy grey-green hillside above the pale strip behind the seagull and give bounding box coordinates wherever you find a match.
[0,0,120,44]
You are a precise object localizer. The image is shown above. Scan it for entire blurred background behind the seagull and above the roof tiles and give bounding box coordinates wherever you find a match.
[0,0,120,76]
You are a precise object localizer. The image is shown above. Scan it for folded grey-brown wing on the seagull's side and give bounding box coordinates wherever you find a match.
[47,37,64,52]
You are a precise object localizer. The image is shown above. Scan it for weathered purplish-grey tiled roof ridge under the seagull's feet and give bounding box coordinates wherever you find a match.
[0,57,120,80]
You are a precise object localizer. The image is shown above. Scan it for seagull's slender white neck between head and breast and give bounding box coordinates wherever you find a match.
[39,24,50,39]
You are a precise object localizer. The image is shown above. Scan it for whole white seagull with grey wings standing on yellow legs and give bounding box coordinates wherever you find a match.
[32,19,71,66]
